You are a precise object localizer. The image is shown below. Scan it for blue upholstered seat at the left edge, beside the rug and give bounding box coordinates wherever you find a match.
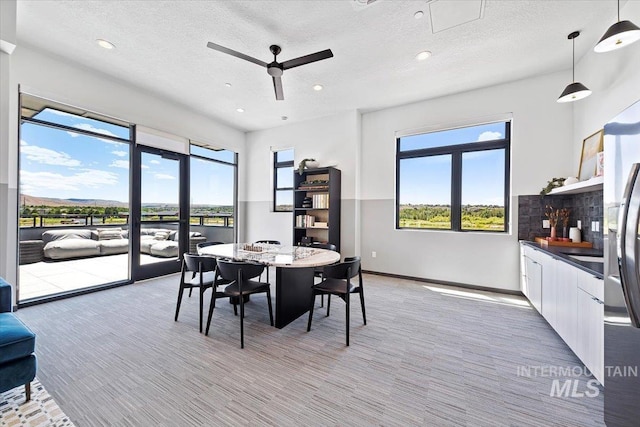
[0,277,36,401]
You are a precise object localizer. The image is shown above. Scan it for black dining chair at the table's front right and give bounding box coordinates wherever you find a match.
[307,257,367,345]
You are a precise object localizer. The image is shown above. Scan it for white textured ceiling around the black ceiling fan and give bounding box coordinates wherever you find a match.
[11,0,625,131]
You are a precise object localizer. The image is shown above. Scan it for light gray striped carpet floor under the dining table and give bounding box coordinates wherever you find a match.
[17,275,603,427]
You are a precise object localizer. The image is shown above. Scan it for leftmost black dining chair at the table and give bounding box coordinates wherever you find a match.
[174,253,228,332]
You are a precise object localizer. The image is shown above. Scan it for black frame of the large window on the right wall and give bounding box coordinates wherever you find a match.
[395,119,511,234]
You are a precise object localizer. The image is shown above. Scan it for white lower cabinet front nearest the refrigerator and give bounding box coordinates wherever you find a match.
[575,271,604,384]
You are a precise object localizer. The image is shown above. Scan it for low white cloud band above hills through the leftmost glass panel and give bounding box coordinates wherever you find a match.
[20,169,118,194]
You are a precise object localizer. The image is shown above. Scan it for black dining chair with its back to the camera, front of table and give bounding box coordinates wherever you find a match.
[205,259,273,348]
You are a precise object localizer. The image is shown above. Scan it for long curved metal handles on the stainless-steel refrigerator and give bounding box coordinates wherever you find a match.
[617,163,640,328]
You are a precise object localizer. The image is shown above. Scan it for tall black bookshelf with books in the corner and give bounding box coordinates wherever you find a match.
[293,167,342,251]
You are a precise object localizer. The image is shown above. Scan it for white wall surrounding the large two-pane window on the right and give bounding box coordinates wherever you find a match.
[360,73,573,290]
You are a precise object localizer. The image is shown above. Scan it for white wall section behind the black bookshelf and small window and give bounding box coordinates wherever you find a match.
[240,111,360,254]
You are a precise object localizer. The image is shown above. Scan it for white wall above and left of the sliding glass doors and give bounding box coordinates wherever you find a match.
[0,46,245,300]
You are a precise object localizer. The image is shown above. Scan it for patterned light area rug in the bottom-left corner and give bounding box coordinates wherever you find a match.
[0,379,74,427]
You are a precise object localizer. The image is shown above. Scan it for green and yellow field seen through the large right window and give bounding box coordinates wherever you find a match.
[399,205,504,231]
